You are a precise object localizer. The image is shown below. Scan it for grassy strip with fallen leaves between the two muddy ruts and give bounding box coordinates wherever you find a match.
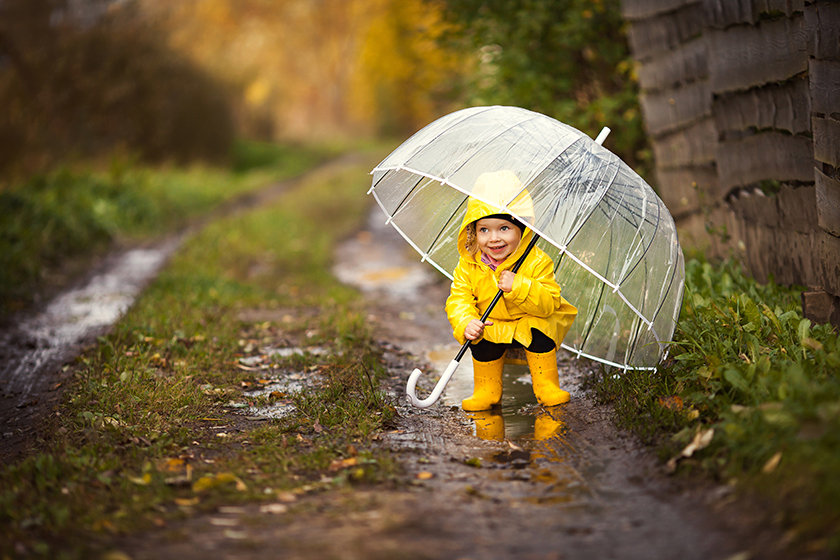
[0,140,396,558]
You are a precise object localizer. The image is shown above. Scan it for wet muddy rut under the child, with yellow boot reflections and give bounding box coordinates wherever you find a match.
[328,208,740,559]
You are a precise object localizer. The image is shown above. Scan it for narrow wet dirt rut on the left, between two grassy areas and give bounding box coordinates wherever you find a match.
[0,153,359,464]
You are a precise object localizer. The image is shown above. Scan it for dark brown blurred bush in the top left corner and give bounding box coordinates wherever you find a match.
[0,0,233,176]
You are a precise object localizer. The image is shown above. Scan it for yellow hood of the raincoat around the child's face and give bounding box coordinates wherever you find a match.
[458,170,534,267]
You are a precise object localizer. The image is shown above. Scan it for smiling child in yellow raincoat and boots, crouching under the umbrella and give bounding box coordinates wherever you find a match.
[446,171,577,411]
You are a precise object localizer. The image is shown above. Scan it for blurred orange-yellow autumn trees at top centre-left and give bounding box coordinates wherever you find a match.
[141,0,466,138]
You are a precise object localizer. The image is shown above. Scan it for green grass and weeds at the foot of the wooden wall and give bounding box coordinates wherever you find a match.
[596,259,840,552]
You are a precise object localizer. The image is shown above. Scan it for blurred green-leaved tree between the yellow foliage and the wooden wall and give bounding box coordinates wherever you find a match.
[433,0,650,174]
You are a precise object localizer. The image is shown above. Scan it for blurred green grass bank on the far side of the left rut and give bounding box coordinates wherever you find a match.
[0,141,337,315]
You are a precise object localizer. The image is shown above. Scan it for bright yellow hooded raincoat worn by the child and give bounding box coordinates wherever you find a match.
[446,171,577,348]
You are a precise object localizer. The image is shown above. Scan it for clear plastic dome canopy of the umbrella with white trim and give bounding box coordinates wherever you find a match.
[369,107,684,369]
